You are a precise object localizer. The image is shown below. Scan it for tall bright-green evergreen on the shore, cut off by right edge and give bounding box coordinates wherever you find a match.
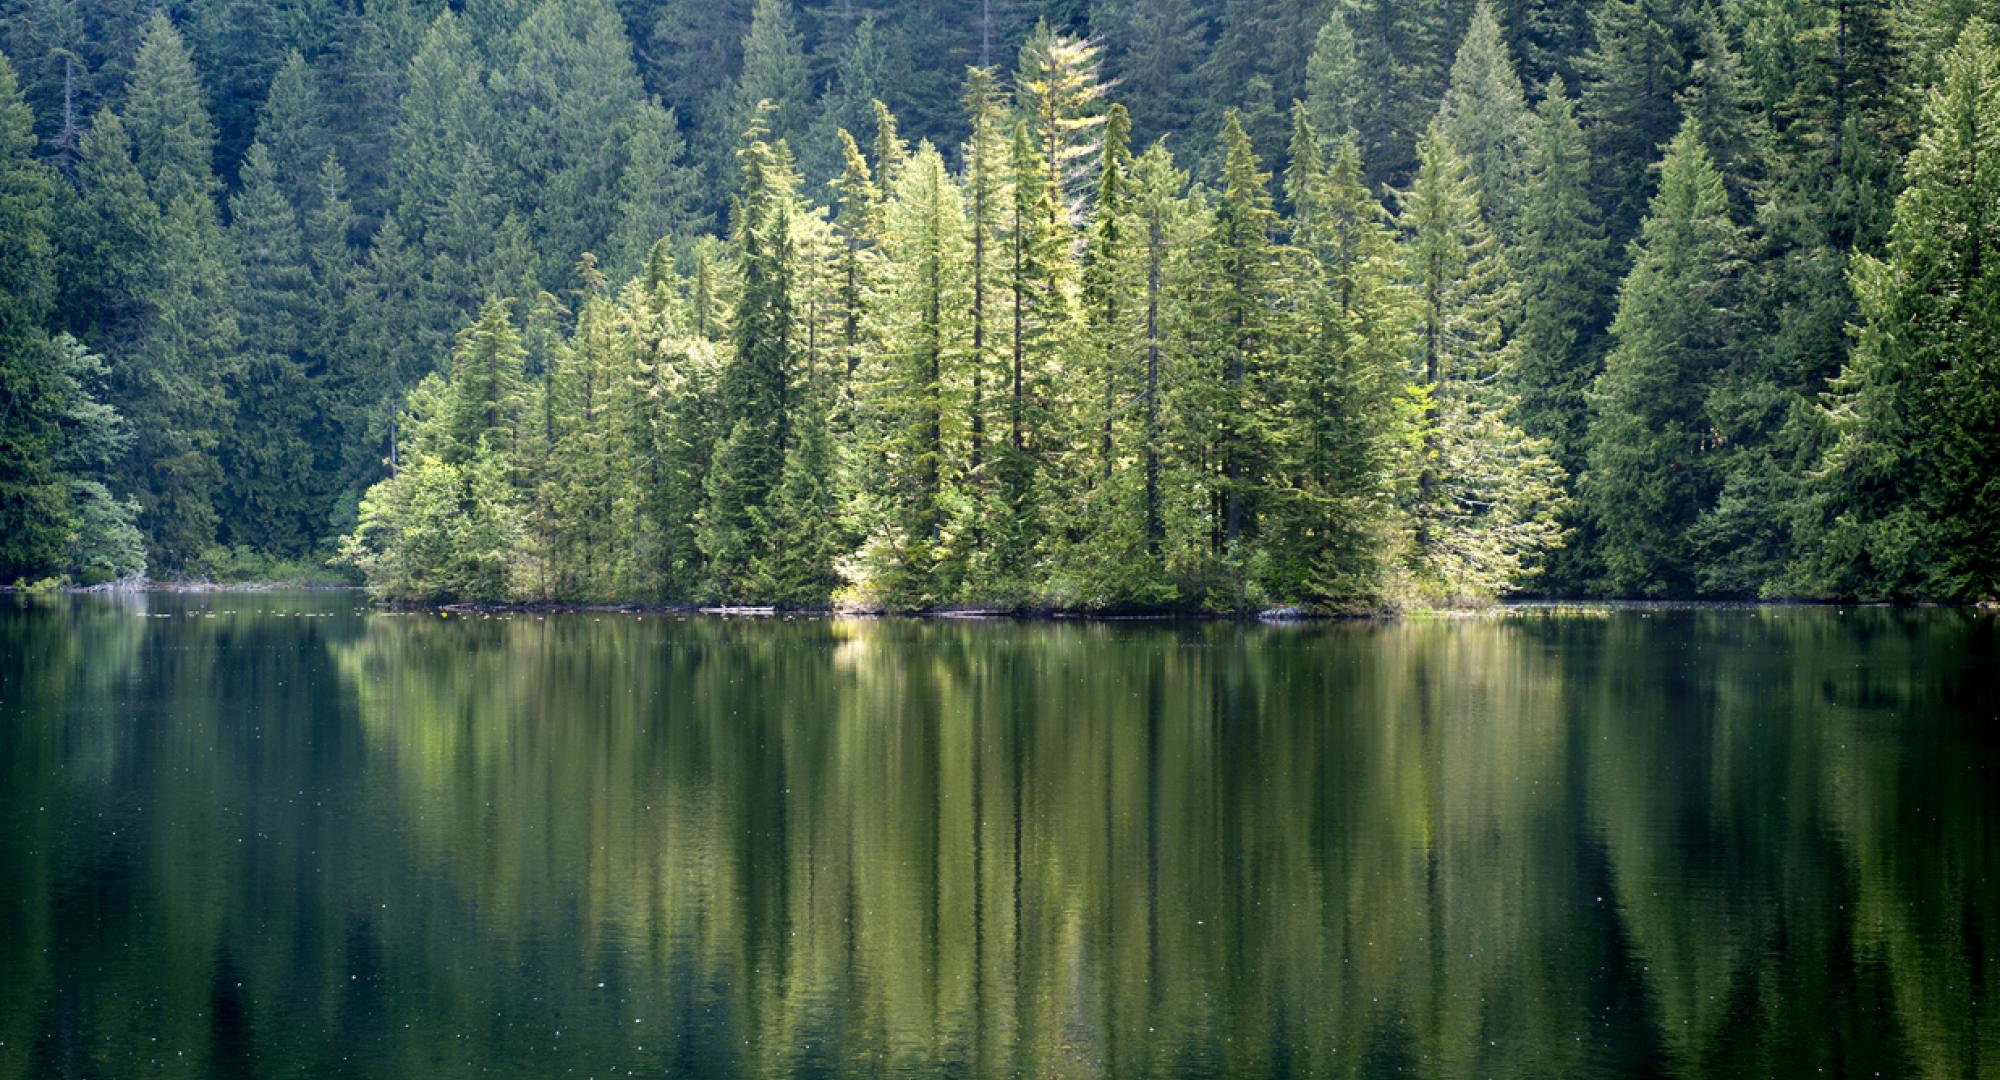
[1800,20,2000,600]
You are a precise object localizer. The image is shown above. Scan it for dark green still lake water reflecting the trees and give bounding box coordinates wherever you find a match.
[0,594,2000,1078]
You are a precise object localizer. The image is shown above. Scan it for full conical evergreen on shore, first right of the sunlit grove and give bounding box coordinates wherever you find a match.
[1582,120,1740,596]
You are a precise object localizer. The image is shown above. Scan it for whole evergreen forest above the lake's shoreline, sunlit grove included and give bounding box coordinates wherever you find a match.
[0,0,2000,612]
